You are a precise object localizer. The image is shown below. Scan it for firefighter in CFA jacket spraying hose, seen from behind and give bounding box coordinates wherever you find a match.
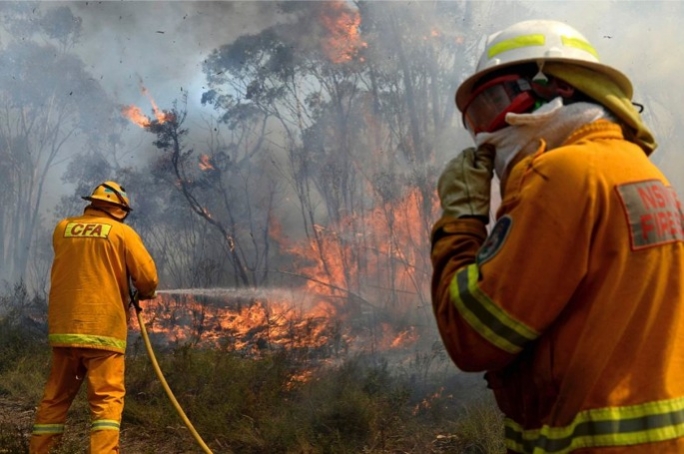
[30,181,157,454]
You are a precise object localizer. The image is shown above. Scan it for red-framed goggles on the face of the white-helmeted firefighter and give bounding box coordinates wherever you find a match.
[463,74,548,136]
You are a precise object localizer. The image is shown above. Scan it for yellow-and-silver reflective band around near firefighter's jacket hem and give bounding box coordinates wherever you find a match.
[505,397,684,454]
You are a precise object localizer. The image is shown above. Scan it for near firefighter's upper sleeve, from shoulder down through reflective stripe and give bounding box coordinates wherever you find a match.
[450,147,596,369]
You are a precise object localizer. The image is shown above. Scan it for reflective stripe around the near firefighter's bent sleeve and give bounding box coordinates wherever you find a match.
[449,264,540,354]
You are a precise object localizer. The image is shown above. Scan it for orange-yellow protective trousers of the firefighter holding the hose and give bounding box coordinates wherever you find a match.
[29,347,126,454]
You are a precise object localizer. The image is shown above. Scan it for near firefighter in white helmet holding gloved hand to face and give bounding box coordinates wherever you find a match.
[431,21,684,454]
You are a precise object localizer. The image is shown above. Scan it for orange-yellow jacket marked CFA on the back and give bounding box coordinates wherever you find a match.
[48,207,157,353]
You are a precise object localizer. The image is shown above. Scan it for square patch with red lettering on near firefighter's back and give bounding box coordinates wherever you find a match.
[616,180,684,250]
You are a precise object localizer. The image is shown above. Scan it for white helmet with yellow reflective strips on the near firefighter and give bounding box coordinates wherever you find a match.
[456,20,632,112]
